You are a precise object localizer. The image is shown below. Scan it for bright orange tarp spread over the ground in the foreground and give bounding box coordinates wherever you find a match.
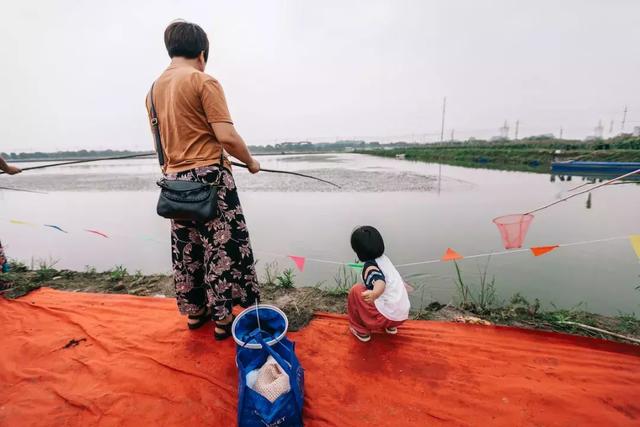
[0,289,640,426]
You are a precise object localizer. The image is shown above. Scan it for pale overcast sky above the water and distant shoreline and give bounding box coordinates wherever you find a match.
[0,0,640,151]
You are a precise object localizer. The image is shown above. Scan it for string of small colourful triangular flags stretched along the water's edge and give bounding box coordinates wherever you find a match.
[2,219,640,272]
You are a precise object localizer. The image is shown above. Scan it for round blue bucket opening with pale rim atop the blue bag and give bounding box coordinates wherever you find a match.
[231,304,289,350]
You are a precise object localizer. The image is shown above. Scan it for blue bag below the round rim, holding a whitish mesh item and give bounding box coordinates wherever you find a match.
[236,334,304,427]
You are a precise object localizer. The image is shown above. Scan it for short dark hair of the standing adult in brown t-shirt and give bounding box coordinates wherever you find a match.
[164,21,209,61]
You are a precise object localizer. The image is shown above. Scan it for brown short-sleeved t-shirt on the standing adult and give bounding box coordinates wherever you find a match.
[146,65,233,173]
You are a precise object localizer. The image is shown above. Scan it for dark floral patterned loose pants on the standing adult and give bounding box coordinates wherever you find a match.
[167,166,259,320]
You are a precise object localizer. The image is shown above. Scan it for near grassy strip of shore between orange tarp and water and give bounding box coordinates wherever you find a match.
[0,263,640,342]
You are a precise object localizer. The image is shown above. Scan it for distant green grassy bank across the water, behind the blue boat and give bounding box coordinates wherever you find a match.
[363,136,640,173]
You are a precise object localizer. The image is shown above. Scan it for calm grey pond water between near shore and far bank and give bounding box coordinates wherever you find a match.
[0,154,640,314]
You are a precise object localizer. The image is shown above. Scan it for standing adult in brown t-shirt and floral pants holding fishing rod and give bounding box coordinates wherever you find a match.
[147,21,260,340]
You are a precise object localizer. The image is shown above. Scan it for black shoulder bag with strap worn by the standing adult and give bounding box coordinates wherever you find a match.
[149,83,224,222]
